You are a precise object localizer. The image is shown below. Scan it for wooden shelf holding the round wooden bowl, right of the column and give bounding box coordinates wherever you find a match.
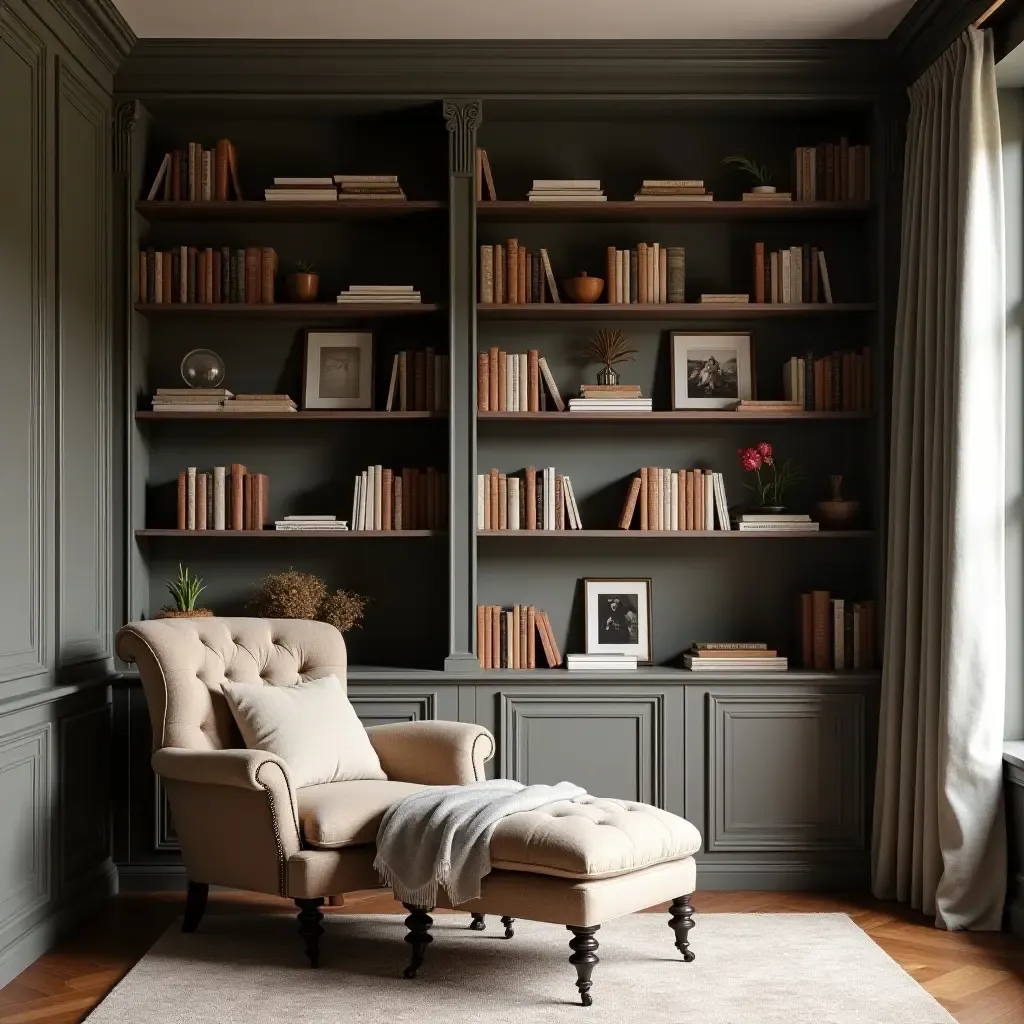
[477,302,874,321]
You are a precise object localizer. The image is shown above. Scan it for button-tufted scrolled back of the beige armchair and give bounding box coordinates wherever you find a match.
[116,618,346,751]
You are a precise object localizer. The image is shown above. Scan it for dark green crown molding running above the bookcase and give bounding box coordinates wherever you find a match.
[116,39,890,99]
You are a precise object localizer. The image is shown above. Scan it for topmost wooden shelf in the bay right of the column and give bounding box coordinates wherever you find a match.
[476,200,874,221]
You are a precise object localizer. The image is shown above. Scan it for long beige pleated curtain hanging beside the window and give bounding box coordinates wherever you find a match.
[871,29,1006,929]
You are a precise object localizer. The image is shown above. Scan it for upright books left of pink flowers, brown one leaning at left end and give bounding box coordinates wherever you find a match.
[618,466,731,530]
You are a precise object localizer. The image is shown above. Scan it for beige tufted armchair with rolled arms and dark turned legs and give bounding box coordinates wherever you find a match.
[117,618,495,967]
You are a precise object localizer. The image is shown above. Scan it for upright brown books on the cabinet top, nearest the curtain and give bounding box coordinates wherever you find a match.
[800,590,878,672]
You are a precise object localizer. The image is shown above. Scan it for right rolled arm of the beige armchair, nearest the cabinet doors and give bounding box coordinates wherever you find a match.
[367,722,495,785]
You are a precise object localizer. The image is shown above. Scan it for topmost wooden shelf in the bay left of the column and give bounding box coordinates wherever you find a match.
[135,200,447,223]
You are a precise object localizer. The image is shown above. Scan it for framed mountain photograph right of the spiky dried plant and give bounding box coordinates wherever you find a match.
[672,331,754,409]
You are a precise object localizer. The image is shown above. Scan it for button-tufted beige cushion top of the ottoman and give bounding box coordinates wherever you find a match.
[490,797,700,879]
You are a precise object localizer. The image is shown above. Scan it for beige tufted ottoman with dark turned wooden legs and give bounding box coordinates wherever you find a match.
[395,797,700,1007]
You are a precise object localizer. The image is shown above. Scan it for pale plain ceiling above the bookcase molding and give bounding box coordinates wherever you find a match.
[108,0,913,39]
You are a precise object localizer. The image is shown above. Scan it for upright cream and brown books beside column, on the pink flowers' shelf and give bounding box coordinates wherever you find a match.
[476,466,583,529]
